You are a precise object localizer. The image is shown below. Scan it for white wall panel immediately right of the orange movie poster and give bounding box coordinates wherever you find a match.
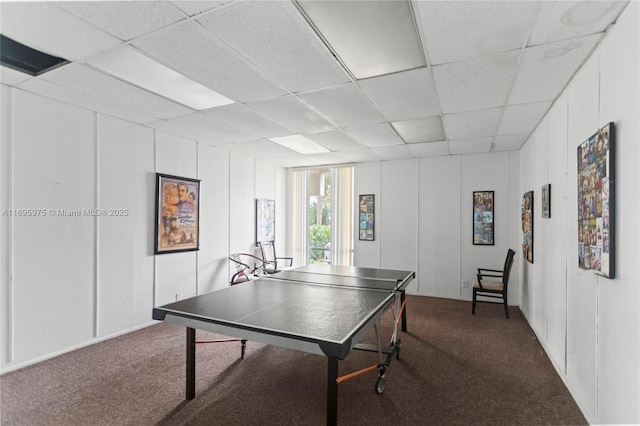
[198,144,229,294]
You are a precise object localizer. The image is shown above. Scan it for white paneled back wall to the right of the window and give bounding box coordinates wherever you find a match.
[354,152,521,302]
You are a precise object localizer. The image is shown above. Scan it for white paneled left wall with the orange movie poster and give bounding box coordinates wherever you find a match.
[0,85,286,372]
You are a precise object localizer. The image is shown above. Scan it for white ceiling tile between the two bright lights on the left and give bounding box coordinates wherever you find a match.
[203,104,292,139]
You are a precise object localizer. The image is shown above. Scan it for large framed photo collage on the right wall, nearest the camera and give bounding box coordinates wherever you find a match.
[577,123,615,278]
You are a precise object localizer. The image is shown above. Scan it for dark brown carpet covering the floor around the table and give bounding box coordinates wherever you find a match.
[0,296,586,426]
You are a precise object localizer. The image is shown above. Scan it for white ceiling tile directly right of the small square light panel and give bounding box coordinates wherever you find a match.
[443,108,502,139]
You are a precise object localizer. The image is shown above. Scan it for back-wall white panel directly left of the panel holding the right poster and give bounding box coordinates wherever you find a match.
[417,156,461,299]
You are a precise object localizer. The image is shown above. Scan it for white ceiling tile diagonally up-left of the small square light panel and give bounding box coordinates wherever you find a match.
[299,83,384,127]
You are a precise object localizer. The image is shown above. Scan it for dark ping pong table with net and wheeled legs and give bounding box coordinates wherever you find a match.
[153,264,415,425]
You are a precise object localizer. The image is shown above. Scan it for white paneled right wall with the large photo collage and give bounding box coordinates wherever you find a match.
[520,2,640,424]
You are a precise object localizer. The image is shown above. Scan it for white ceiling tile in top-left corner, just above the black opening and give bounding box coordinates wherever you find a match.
[0,2,122,61]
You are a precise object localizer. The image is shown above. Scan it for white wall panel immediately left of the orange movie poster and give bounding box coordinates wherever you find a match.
[97,115,155,336]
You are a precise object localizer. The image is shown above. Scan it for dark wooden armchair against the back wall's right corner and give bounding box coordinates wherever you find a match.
[471,249,516,319]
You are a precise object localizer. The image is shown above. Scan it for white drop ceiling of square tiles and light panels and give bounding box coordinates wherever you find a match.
[0,0,628,167]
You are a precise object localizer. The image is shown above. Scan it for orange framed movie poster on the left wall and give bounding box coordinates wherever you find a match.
[154,173,200,254]
